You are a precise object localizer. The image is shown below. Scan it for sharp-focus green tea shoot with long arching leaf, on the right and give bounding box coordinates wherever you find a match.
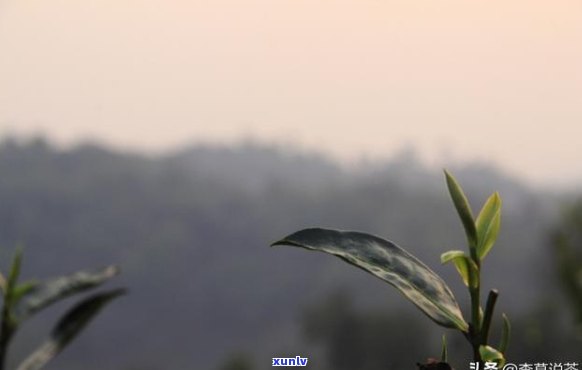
[271,171,510,367]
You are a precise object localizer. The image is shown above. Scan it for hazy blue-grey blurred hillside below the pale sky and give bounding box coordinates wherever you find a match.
[0,139,576,370]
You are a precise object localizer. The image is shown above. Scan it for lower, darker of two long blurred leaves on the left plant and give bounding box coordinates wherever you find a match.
[17,289,125,370]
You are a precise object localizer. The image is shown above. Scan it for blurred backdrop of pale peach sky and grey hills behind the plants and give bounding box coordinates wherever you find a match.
[0,0,582,370]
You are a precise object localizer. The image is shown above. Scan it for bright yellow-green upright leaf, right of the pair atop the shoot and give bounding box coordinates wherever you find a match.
[476,192,501,259]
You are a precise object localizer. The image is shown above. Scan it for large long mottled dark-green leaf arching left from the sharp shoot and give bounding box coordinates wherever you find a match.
[272,228,468,332]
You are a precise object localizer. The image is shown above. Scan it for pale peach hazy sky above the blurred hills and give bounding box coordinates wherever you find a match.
[0,0,582,183]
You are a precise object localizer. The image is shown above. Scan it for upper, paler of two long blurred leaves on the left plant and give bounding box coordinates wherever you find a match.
[16,266,119,320]
